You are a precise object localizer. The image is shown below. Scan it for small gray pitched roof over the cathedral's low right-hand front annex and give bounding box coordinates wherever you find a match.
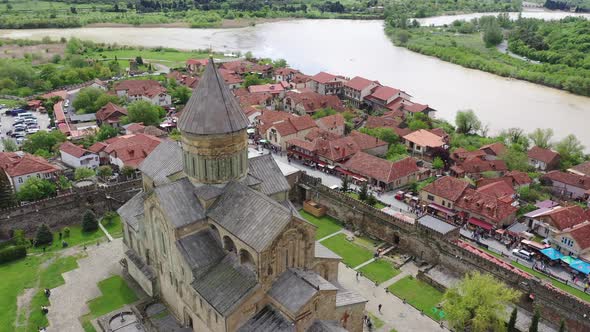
[268,269,319,314]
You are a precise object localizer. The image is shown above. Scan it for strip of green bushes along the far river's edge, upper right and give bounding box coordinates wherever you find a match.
[385,27,590,96]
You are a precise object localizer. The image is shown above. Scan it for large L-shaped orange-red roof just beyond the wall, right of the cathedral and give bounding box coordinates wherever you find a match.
[343,152,419,183]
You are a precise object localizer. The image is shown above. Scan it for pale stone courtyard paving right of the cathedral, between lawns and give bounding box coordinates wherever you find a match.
[338,263,448,332]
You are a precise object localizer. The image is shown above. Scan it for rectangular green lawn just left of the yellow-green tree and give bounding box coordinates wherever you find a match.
[388,276,443,320]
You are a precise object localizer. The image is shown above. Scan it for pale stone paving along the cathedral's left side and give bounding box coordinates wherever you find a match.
[47,239,123,332]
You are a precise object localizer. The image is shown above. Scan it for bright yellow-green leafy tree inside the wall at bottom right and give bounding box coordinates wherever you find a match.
[443,272,518,331]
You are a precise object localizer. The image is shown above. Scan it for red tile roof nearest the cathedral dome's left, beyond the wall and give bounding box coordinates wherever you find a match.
[104,134,162,167]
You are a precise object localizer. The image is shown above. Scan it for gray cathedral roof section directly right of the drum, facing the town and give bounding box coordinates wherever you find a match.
[248,154,291,195]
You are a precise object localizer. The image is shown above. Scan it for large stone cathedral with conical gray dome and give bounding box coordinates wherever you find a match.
[118,60,366,332]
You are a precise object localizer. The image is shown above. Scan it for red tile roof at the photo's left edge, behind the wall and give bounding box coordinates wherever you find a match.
[0,152,60,177]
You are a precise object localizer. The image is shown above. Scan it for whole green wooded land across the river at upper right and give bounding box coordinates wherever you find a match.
[386,15,590,96]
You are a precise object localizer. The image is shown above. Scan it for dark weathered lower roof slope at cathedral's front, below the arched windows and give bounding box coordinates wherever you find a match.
[191,255,258,316]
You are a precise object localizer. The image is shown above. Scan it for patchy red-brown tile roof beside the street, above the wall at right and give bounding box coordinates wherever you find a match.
[455,189,517,224]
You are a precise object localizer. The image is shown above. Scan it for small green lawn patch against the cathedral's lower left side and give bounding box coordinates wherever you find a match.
[88,275,137,317]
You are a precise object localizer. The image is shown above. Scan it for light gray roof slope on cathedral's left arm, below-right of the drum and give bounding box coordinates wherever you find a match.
[154,178,206,228]
